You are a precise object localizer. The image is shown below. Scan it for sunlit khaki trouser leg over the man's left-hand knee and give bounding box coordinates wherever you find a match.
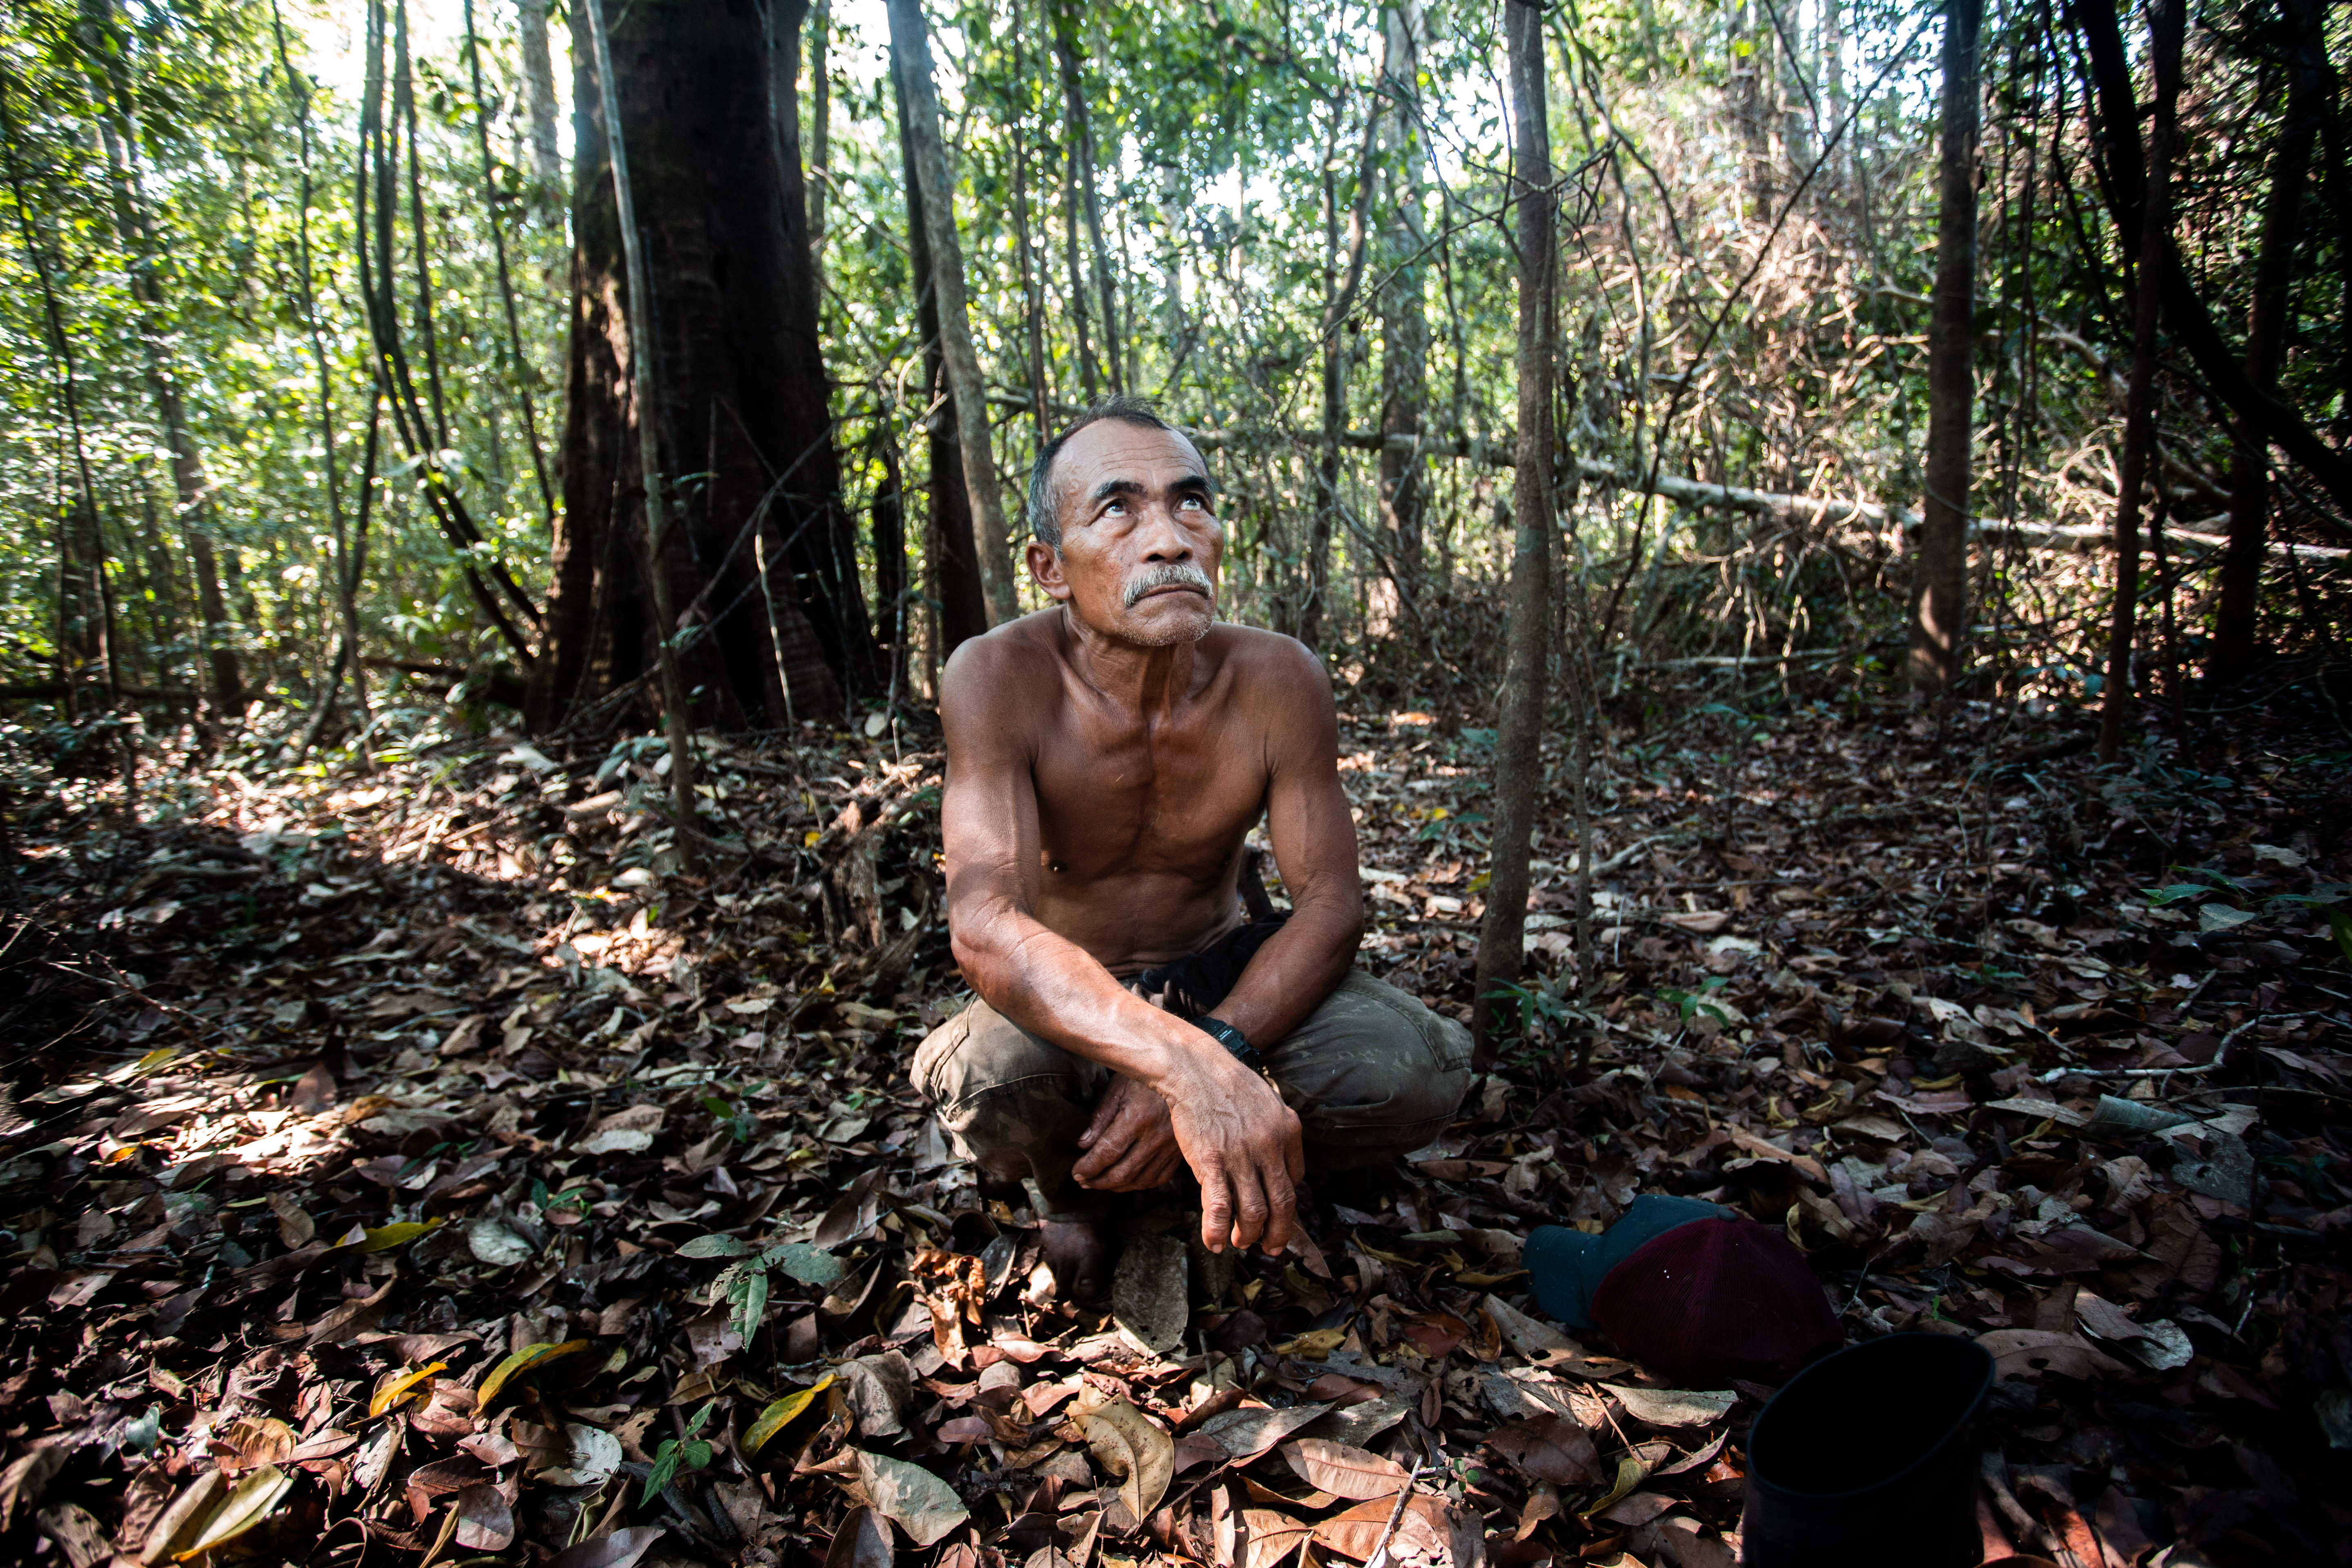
[913,997,1110,1199]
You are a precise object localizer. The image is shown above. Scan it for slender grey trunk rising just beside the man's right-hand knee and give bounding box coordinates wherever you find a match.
[1470,0,1557,1046]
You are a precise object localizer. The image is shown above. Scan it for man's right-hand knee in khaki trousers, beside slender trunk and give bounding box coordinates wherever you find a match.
[1272,971,1470,1168]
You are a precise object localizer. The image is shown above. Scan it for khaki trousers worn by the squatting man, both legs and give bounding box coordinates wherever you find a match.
[913,969,1470,1196]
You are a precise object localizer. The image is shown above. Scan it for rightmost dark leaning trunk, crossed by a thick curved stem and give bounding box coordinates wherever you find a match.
[2206,0,2326,686]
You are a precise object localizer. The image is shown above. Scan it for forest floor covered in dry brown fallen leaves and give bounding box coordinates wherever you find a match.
[0,696,2352,1568]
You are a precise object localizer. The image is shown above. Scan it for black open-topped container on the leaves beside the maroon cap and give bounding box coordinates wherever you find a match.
[1740,1333,1992,1568]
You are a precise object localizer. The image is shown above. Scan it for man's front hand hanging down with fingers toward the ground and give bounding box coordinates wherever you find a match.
[1152,1041,1308,1255]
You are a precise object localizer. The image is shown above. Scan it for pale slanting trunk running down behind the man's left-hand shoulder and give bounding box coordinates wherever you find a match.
[889,0,1021,625]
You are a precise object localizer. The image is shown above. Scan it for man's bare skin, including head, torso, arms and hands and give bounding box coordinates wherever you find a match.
[941,421,1364,1267]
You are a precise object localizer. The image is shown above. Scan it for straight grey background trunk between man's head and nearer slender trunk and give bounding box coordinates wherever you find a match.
[1381,0,1430,642]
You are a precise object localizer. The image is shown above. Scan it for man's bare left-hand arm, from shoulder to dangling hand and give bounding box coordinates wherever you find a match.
[938,637,1303,1251]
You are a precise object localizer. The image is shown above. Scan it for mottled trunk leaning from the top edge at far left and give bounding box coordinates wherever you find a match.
[82,0,245,724]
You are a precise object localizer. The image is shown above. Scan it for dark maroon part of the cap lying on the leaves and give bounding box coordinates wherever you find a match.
[1592,1218,1844,1387]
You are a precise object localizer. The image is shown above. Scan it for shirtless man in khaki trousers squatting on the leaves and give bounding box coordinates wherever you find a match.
[915,400,1470,1295]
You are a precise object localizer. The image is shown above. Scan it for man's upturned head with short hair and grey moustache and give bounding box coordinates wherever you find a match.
[1028,419,1225,646]
